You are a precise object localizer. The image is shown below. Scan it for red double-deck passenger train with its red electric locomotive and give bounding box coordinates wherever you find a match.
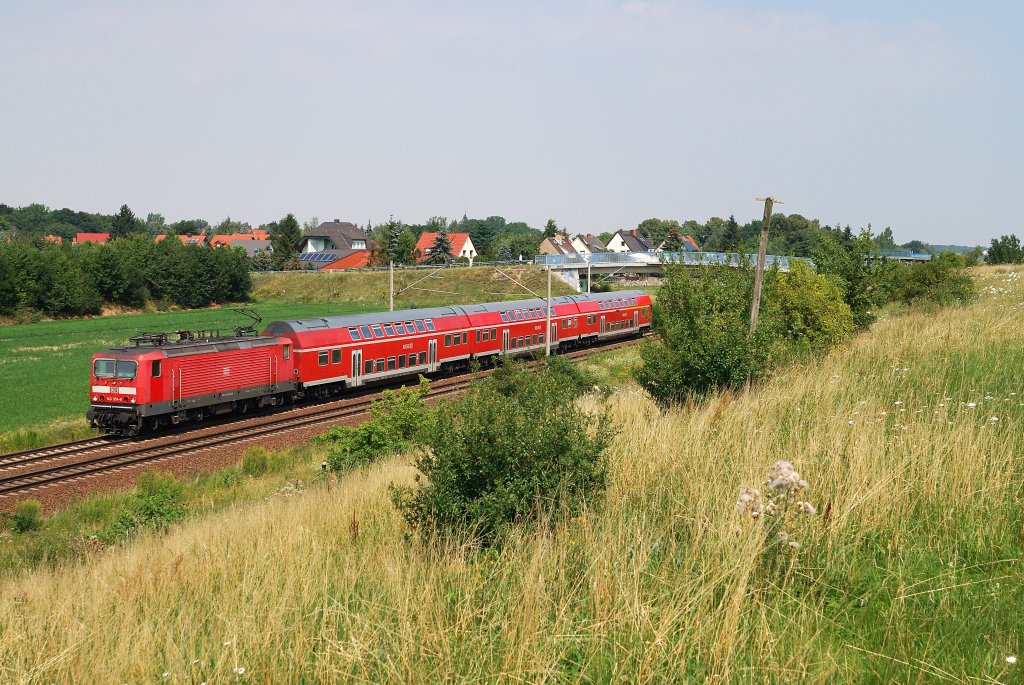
[86,291,651,435]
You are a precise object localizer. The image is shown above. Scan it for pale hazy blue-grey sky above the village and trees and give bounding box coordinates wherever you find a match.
[0,0,1024,244]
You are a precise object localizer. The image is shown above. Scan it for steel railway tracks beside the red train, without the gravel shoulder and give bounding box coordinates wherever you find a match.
[0,338,637,498]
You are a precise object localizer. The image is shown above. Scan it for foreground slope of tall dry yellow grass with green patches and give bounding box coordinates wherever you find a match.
[0,270,1024,683]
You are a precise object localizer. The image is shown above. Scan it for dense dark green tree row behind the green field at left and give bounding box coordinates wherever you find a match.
[0,234,252,316]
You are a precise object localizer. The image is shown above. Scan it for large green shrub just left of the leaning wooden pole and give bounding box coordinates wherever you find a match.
[635,265,779,403]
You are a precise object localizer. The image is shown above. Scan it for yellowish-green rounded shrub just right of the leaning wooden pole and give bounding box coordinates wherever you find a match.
[765,262,854,351]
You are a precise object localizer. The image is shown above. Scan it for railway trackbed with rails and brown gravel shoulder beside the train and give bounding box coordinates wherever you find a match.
[0,338,637,512]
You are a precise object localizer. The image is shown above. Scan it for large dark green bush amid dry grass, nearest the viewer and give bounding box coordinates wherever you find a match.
[392,363,610,545]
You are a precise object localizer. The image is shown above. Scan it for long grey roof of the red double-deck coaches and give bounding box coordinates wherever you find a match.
[263,290,643,335]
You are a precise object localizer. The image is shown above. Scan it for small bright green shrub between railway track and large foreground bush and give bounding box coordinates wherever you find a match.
[314,377,430,471]
